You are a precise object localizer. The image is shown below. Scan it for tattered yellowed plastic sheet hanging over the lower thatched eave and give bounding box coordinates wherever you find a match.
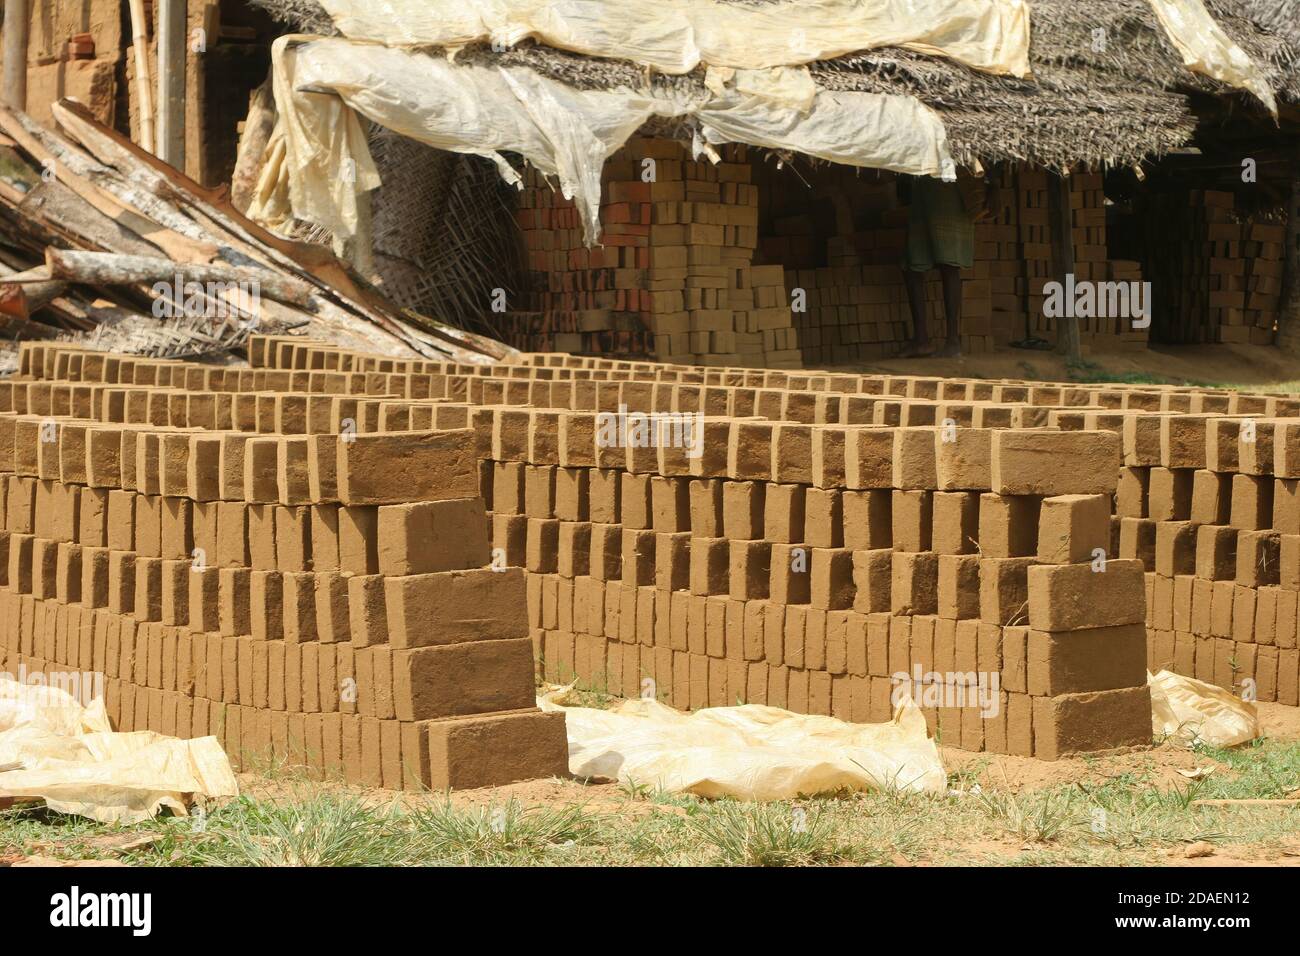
[261,38,956,243]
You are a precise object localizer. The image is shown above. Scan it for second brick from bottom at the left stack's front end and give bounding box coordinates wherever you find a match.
[393,637,534,721]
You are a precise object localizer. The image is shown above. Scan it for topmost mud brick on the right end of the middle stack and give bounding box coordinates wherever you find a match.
[992,431,1119,496]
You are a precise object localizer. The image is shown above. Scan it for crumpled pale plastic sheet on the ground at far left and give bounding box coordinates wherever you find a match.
[0,676,239,823]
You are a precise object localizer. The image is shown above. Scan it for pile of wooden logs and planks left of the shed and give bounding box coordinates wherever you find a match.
[0,99,512,375]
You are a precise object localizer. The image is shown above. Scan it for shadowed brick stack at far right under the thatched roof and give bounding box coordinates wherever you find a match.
[1147,190,1286,345]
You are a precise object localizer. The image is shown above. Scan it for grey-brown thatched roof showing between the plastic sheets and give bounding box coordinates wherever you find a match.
[252,0,1300,168]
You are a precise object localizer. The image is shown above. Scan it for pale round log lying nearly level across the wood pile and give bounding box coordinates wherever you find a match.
[46,247,313,308]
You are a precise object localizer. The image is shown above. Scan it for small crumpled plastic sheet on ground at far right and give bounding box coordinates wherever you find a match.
[1147,671,1260,747]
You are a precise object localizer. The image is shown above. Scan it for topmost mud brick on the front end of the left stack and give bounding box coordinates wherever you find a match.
[337,429,478,505]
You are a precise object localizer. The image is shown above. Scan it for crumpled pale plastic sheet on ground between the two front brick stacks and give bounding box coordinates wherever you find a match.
[537,685,948,801]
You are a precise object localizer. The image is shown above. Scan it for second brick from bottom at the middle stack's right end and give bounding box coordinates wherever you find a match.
[1028,624,1147,697]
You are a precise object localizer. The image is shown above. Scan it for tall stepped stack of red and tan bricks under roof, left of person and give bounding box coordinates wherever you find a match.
[508,138,798,367]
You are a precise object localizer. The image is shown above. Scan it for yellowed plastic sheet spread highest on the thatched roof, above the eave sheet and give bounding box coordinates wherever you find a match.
[321,0,1030,77]
